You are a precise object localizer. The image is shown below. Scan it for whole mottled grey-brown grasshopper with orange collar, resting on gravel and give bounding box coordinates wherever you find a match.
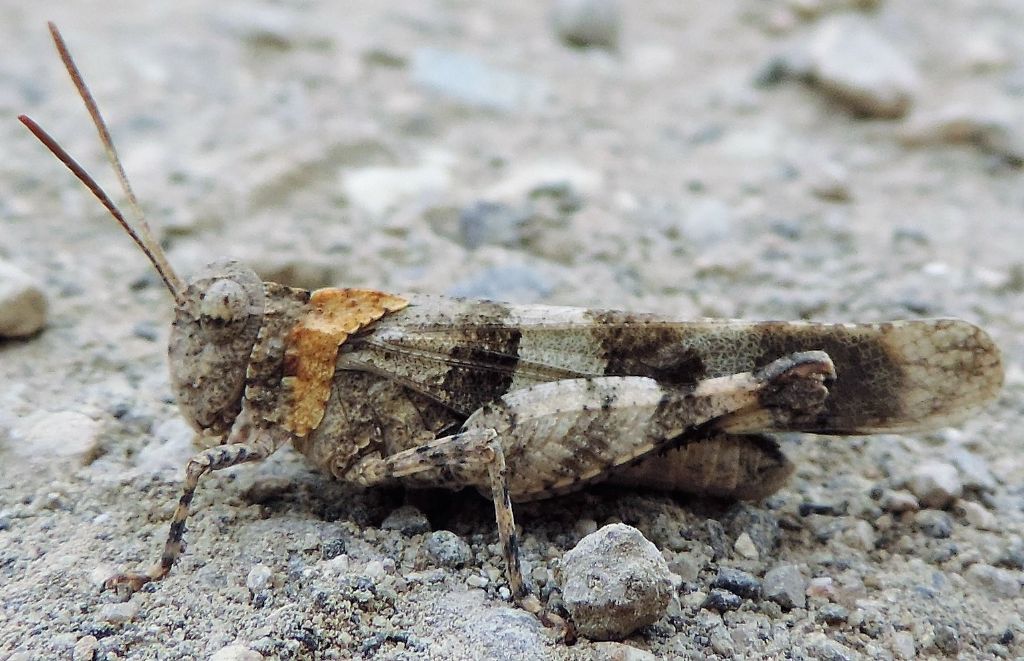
[20,24,1002,626]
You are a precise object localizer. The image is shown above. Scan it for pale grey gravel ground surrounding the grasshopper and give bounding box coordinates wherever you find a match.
[0,0,1024,661]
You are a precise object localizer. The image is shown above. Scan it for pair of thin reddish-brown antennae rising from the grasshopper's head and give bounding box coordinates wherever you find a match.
[17,21,185,304]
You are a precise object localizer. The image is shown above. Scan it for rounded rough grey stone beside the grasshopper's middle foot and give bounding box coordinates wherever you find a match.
[561,524,672,640]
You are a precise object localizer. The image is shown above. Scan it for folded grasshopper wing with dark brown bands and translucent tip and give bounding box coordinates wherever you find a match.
[338,296,1002,434]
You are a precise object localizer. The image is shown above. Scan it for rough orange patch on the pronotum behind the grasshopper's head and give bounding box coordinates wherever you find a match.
[282,289,409,436]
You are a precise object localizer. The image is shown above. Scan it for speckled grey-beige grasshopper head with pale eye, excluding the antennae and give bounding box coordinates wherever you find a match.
[168,260,263,436]
